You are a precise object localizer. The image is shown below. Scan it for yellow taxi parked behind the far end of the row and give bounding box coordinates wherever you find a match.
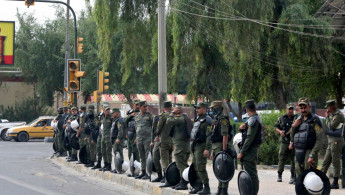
[6,116,55,142]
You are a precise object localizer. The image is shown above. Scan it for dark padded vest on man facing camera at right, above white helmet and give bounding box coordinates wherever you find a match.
[294,120,316,150]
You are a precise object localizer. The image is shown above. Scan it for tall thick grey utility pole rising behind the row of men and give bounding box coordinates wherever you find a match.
[158,0,167,112]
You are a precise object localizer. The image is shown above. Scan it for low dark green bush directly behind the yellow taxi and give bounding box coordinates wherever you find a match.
[0,98,52,123]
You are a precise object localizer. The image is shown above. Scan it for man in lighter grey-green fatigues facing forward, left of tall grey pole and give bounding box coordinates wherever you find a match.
[135,101,153,179]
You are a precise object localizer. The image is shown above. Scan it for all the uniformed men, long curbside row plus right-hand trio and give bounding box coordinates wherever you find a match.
[52,98,344,194]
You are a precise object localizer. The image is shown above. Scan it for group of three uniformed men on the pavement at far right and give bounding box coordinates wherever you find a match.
[275,98,344,189]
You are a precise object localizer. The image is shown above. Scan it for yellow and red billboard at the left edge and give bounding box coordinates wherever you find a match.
[0,21,14,65]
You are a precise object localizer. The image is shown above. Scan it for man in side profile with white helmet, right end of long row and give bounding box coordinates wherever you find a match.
[237,99,263,194]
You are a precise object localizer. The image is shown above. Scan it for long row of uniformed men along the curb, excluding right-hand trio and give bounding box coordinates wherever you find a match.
[51,100,263,194]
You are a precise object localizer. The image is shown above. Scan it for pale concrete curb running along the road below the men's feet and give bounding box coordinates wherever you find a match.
[51,156,189,195]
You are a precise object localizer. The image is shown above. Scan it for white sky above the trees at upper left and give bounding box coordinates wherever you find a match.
[0,0,94,27]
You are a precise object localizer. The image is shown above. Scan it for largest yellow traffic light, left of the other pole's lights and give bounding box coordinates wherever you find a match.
[67,59,86,92]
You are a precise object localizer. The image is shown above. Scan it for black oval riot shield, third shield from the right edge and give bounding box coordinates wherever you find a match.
[212,151,235,182]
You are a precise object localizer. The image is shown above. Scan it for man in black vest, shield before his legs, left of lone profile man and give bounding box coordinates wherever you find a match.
[211,101,233,195]
